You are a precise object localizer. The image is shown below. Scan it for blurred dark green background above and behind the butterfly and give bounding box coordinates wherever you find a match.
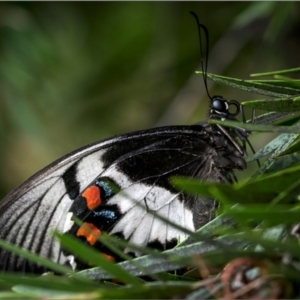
[0,2,300,198]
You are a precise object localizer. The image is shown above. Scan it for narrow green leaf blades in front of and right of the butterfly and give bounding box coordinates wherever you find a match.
[0,69,300,299]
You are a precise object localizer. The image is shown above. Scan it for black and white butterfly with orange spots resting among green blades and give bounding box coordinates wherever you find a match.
[0,17,250,272]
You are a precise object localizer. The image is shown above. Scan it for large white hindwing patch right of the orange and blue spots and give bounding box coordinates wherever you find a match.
[102,167,195,255]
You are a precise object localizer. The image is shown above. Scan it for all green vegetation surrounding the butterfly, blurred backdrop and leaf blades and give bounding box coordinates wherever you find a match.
[0,2,300,299]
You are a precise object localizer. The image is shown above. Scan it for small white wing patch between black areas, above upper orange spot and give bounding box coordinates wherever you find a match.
[76,150,106,191]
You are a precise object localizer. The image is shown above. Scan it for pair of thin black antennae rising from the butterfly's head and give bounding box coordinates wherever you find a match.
[190,11,212,99]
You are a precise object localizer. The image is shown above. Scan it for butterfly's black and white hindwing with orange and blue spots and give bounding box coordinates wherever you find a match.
[62,126,214,264]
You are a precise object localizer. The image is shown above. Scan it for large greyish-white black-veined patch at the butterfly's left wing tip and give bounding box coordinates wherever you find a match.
[0,174,72,261]
